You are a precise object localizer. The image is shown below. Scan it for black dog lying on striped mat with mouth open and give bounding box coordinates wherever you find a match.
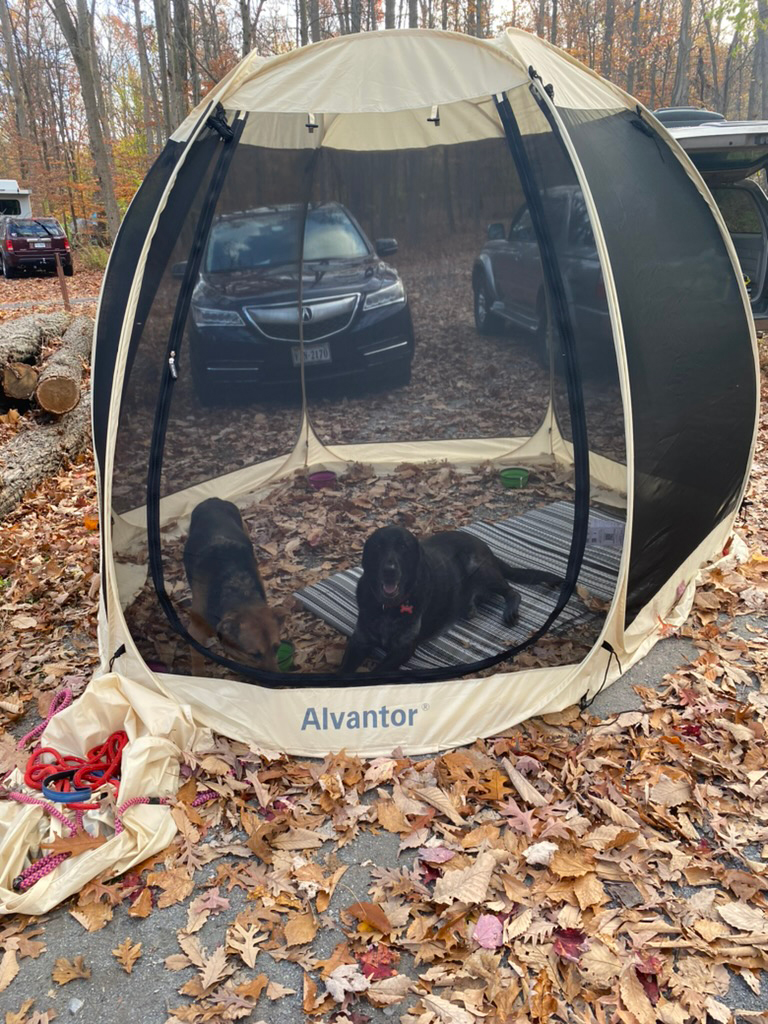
[339,526,562,672]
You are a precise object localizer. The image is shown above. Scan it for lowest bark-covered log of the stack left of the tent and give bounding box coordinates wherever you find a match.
[0,394,91,519]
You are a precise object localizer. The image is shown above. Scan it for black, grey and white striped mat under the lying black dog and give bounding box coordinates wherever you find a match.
[294,502,624,669]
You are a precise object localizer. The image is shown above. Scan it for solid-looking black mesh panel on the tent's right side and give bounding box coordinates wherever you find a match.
[562,111,756,623]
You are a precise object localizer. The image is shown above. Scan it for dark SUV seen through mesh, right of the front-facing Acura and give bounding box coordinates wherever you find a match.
[472,185,611,365]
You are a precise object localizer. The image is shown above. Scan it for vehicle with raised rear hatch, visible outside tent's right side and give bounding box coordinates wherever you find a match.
[653,106,768,330]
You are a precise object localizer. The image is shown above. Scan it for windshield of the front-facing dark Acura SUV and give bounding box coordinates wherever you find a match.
[206,206,369,273]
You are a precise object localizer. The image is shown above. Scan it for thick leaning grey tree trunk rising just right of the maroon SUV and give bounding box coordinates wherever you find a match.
[51,0,120,240]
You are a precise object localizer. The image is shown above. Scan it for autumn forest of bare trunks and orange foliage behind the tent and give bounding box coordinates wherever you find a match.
[0,0,768,249]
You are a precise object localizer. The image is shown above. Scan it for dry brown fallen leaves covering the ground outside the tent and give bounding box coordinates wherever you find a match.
[0,274,768,1024]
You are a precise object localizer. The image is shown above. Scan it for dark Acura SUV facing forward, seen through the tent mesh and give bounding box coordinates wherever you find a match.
[186,203,414,401]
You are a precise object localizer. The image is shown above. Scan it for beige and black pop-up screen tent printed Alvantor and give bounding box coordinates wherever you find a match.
[93,31,757,754]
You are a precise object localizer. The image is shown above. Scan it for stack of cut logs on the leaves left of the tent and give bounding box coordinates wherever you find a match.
[0,312,93,518]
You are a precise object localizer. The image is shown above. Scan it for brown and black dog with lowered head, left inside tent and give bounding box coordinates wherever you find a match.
[184,498,280,672]
